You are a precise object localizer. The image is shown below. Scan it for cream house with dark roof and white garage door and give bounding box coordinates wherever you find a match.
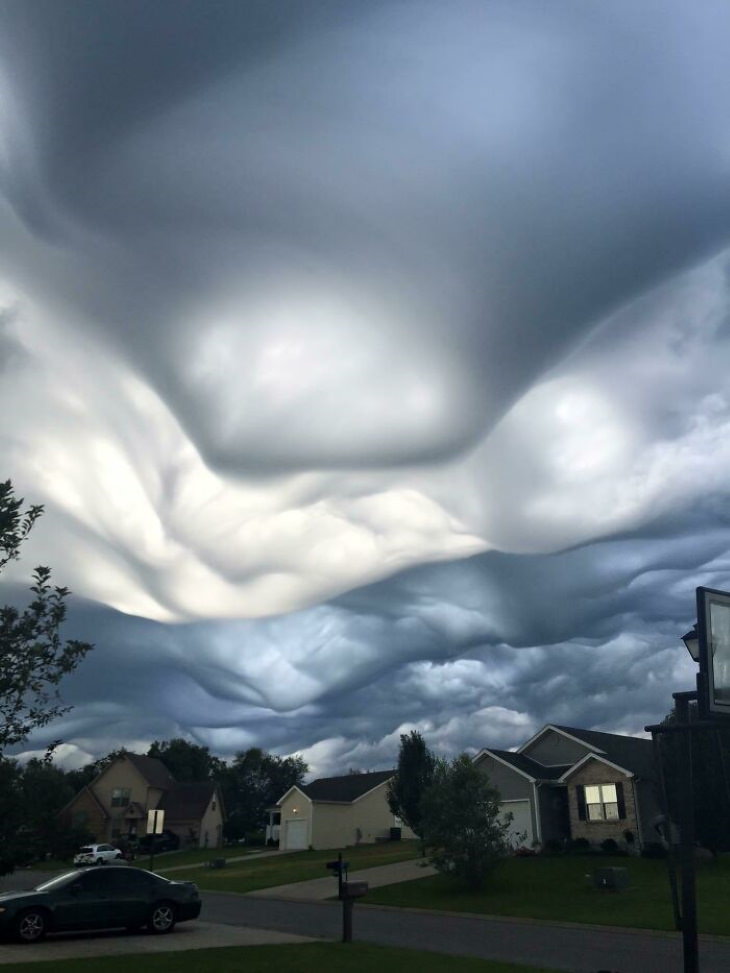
[271,770,415,851]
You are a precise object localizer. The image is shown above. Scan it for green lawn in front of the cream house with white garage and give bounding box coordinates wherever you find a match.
[162,841,420,895]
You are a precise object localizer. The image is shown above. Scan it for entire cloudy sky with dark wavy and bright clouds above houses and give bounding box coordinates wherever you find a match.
[0,0,730,775]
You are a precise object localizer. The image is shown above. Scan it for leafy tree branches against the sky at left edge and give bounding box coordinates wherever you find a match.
[0,480,91,751]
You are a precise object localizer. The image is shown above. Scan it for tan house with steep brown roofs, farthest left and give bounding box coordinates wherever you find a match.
[60,753,223,848]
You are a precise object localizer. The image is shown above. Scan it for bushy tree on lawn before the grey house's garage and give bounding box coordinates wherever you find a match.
[421,753,510,889]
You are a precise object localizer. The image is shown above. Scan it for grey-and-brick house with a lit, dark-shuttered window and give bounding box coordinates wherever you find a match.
[474,724,660,849]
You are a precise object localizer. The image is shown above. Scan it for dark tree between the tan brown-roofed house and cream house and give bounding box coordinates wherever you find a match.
[220,747,309,841]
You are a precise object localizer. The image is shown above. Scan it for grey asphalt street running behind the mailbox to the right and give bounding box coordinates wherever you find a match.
[203,892,730,973]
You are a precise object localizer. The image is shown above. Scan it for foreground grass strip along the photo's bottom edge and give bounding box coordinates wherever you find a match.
[2,943,550,973]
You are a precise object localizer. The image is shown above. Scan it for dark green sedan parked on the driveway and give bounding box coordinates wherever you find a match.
[0,865,200,943]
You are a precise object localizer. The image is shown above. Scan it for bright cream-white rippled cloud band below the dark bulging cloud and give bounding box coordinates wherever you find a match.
[0,288,484,620]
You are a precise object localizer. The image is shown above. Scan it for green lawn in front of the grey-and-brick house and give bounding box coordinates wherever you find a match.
[363,855,730,936]
